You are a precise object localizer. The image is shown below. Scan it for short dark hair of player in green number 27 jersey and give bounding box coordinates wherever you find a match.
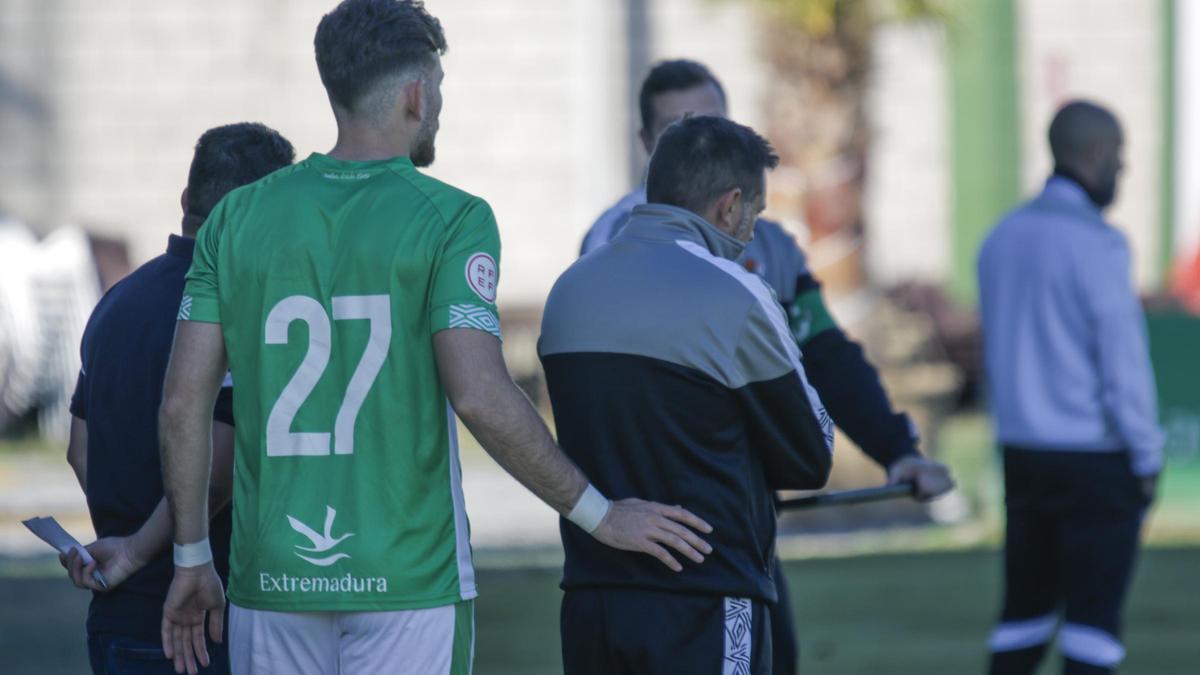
[313,0,446,112]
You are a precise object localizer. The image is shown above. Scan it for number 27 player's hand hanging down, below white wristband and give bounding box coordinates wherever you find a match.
[162,562,224,675]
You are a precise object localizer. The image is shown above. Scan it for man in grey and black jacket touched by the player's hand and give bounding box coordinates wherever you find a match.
[539,117,833,674]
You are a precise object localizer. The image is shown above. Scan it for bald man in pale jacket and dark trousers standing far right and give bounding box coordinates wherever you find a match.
[979,101,1164,675]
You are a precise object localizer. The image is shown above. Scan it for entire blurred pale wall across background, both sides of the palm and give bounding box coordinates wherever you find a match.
[0,0,1176,299]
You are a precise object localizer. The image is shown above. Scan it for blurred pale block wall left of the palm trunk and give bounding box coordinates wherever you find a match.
[0,0,764,306]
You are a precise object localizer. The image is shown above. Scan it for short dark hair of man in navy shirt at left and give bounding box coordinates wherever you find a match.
[184,121,295,232]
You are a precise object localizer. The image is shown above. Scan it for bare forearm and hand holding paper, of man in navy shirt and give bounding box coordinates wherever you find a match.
[64,422,234,592]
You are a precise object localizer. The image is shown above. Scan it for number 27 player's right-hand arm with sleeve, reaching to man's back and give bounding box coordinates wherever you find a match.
[430,199,712,571]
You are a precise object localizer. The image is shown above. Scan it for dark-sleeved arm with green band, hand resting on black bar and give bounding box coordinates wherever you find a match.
[788,270,954,500]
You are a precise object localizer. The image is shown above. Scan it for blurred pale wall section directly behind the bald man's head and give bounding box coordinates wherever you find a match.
[1018,0,1171,289]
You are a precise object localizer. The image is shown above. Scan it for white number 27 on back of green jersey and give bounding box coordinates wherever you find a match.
[266,295,391,456]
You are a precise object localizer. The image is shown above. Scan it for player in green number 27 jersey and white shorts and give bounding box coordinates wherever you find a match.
[153,0,712,675]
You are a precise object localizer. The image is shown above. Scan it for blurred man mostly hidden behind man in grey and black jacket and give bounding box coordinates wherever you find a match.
[580,59,953,675]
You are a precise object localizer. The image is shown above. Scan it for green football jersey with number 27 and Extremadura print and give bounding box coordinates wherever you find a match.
[180,154,500,611]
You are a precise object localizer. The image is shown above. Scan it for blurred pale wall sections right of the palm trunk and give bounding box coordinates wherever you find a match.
[865,0,1171,291]
